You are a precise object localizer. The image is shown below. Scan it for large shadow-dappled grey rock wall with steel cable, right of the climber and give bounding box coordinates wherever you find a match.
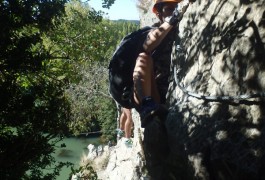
[166,0,265,179]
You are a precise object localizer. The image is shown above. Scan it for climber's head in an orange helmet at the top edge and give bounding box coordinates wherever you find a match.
[153,0,182,22]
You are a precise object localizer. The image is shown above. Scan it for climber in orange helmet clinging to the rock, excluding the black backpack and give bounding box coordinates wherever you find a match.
[133,0,187,128]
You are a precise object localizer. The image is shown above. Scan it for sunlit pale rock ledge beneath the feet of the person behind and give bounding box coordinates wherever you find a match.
[87,109,148,180]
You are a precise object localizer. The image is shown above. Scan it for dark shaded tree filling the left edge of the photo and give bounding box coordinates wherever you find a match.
[0,0,72,179]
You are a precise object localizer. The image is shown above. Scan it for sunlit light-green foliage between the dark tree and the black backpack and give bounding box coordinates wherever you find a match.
[46,1,139,140]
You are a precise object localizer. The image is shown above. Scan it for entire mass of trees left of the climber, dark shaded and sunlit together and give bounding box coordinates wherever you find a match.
[0,0,139,179]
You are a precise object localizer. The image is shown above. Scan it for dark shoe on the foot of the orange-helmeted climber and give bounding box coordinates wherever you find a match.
[139,98,168,128]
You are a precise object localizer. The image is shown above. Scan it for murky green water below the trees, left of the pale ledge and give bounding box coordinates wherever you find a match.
[54,137,100,180]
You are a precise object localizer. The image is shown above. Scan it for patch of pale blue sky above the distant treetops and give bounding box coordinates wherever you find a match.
[88,0,140,20]
